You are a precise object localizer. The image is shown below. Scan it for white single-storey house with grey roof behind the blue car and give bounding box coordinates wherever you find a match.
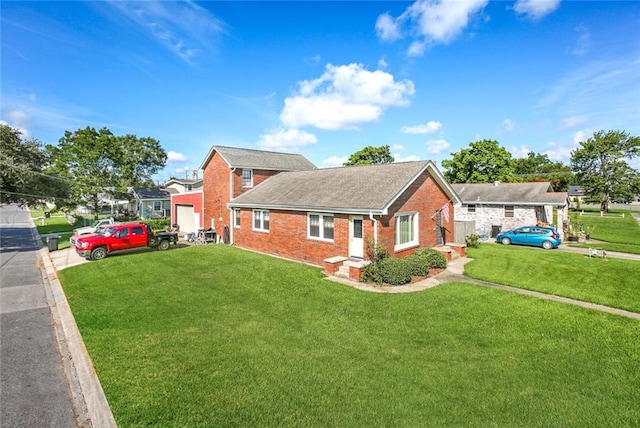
[452,182,568,238]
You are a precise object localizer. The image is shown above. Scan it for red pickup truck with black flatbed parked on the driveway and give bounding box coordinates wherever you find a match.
[75,223,178,260]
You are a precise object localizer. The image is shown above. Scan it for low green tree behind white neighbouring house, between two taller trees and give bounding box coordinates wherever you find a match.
[514,152,575,192]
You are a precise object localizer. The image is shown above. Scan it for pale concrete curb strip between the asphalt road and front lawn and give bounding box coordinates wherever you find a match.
[31,220,117,428]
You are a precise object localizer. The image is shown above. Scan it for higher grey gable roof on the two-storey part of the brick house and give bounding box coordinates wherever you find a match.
[200,146,316,171]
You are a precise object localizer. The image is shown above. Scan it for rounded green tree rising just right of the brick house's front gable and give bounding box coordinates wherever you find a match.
[442,140,515,183]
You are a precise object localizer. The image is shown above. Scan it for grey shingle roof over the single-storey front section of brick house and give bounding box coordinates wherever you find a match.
[228,161,459,215]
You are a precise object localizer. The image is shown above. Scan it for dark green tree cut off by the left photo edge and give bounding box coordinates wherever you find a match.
[0,125,69,205]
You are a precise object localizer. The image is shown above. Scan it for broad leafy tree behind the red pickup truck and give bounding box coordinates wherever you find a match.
[47,127,167,216]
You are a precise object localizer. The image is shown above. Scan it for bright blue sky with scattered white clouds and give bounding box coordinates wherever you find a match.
[0,0,640,181]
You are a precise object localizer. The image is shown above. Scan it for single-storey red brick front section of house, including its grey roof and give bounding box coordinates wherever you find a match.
[228,161,462,265]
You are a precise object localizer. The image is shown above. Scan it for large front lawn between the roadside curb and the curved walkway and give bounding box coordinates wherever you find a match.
[59,245,640,427]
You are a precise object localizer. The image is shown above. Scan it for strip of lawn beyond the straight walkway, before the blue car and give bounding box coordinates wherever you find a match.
[464,244,640,313]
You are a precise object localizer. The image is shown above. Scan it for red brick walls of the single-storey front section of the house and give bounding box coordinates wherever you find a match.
[234,168,453,266]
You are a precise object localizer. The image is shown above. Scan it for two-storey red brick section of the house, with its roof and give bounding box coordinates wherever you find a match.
[200,146,316,242]
